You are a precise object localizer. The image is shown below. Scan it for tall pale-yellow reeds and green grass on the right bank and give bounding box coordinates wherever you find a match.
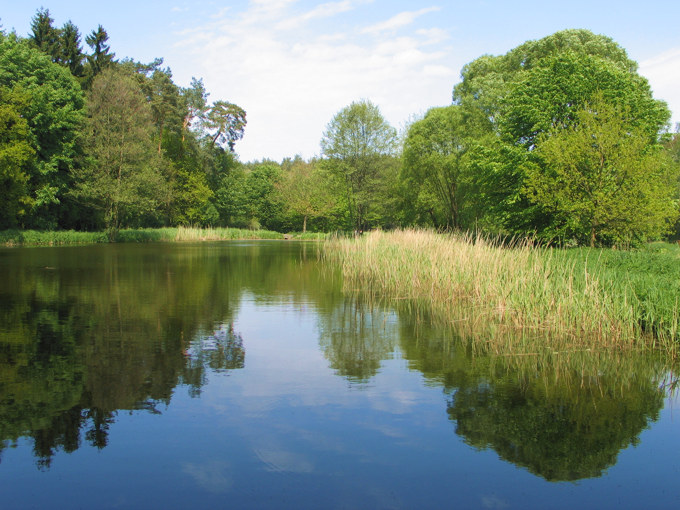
[325,230,680,357]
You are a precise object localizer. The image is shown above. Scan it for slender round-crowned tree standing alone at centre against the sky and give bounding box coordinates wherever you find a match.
[321,100,397,230]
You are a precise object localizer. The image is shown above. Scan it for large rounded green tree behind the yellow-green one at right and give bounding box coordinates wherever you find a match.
[454,30,670,240]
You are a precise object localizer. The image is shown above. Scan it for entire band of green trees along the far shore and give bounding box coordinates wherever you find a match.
[0,9,680,246]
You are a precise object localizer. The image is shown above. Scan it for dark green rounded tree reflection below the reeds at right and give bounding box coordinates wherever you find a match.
[402,318,666,481]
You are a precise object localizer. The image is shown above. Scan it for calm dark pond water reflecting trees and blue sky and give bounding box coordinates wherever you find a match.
[0,242,680,509]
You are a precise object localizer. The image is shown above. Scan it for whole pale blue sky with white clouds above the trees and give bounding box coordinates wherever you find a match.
[0,0,680,161]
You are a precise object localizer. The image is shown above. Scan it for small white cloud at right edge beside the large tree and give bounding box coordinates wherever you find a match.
[639,48,680,128]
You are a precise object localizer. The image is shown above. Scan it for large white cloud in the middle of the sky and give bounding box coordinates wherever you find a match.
[173,0,456,161]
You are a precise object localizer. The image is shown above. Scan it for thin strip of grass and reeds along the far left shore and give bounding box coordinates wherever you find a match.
[0,227,327,246]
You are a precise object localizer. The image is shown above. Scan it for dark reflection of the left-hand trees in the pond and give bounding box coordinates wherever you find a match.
[0,246,249,469]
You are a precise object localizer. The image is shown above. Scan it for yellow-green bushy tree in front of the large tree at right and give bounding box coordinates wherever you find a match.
[526,95,678,247]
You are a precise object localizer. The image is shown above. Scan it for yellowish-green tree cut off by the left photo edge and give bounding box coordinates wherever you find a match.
[0,87,35,229]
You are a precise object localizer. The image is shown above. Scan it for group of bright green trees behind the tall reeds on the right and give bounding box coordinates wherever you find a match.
[322,30,680,246]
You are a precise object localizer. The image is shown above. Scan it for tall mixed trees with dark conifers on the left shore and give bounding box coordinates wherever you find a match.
[0,9,246,238]
